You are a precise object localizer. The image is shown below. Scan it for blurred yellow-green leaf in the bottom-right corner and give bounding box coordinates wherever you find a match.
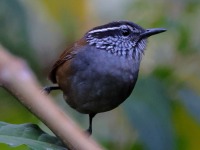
[173,101,200,150]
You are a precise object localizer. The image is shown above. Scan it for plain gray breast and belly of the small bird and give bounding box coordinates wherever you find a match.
[64,49,139,113]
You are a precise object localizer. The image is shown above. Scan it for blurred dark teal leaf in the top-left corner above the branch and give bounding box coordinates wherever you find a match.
[0,0,40,72]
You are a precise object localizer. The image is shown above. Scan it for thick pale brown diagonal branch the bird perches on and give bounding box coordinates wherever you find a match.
[0,45,101,150]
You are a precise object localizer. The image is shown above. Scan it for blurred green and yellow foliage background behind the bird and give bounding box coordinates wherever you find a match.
[0,0,200,150]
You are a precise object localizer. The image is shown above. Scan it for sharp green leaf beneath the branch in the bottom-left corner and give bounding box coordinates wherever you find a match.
[0,122,66,150]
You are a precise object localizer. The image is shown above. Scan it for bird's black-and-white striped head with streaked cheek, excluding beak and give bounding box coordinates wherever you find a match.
[85,21,146,59]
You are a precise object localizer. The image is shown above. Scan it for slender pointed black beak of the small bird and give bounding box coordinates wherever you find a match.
[140,28,167,38]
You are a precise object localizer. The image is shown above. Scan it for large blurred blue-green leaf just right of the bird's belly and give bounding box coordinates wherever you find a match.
[125,77,175,150]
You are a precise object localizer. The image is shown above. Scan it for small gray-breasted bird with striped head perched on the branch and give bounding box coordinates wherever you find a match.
[44,21,166,134]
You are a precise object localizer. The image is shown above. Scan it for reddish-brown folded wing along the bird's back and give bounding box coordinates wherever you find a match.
[48,38,87,83]
